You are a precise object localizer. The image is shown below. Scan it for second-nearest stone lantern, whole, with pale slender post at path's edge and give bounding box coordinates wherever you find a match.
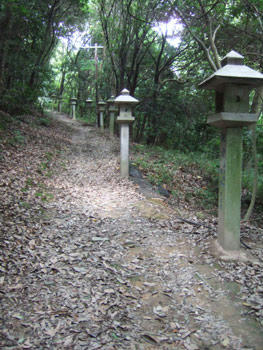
[115,89,139,177]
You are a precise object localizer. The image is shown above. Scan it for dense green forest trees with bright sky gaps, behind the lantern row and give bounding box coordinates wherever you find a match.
[0,0,263,150]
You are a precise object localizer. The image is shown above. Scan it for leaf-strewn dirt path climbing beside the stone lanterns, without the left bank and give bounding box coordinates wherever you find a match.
[1,114,263,350]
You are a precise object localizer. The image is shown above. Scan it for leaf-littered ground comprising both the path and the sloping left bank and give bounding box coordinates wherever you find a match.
[0,113,263,350]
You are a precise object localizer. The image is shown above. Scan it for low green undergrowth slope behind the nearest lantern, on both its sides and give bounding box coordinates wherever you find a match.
[132,140,263,224]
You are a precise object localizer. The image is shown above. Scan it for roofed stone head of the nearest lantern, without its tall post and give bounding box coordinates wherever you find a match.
[199,51,263,128]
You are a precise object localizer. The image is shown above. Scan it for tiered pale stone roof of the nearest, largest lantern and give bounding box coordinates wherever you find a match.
[199,50,263,90]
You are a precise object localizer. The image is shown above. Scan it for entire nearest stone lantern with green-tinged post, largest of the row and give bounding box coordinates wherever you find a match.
[199,51,263,253]
